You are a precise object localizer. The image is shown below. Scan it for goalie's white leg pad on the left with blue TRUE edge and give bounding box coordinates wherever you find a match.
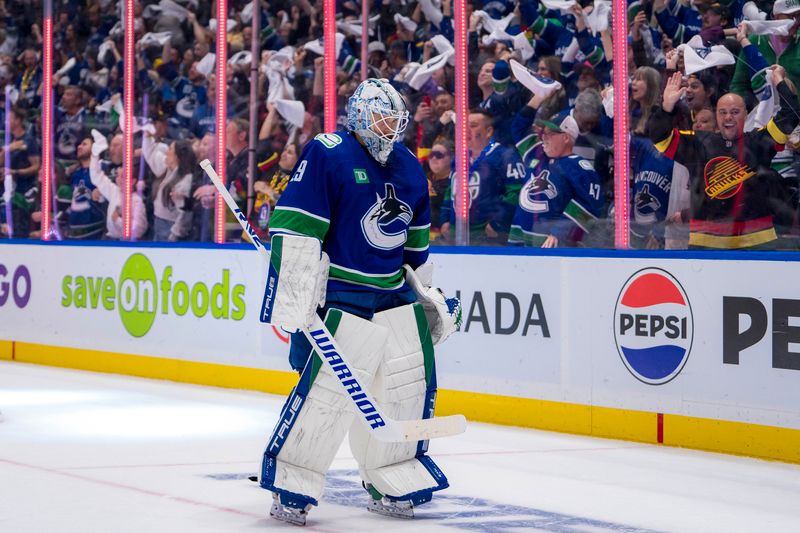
[260,309,388,502]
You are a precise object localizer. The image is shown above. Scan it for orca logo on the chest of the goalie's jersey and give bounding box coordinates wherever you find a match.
[361,183,413,250]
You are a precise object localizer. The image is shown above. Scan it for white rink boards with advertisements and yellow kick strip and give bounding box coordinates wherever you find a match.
[0,243,800,462]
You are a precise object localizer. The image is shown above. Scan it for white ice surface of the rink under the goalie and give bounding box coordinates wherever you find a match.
[0,362,800,533]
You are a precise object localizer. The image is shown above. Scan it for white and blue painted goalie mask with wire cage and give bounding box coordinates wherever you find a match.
[347,78,408,165]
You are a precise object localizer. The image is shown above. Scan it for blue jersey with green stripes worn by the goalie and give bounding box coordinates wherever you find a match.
[269,131,431,293]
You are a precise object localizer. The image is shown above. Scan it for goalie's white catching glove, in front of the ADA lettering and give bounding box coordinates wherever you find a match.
[404,263,461,345]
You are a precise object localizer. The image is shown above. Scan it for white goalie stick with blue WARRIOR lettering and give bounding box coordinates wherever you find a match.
[200,159,467,442]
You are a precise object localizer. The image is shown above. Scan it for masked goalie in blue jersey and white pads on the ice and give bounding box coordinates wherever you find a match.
[260,78,461,524]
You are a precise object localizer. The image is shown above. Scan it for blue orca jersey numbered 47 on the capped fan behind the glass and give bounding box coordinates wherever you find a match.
[508,143,603,246]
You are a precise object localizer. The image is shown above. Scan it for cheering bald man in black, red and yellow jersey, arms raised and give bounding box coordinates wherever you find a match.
[648,65,800,249]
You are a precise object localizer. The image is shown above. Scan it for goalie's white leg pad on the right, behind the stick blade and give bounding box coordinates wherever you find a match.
[350,304,448,503]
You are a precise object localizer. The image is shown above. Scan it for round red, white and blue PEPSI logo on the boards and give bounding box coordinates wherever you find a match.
[614,268,694,385]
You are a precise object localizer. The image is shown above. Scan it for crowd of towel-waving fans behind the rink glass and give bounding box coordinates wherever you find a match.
[0,0,800,249]
